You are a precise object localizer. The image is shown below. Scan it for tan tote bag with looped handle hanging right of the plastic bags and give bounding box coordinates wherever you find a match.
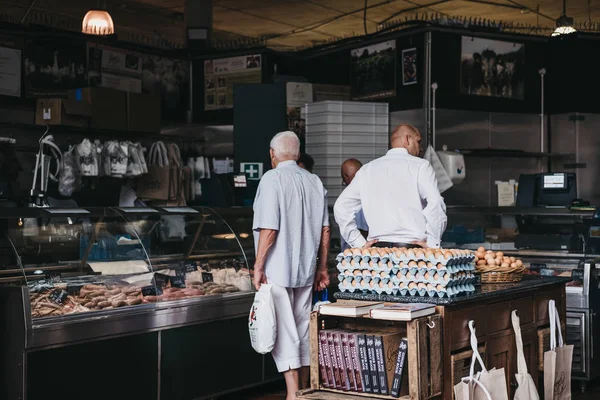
[136,141,171,201]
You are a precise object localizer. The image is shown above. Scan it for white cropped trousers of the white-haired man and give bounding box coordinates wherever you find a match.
[271,285,312,372]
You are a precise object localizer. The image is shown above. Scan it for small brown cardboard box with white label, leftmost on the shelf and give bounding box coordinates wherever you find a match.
[35,98,92,128]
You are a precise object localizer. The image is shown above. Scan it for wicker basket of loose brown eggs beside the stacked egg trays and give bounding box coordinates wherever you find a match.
[475,247,525,283]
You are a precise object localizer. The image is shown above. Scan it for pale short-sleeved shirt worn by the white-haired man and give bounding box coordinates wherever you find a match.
[252,161,329,288]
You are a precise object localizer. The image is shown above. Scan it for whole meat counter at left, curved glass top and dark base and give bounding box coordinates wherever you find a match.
[0,207,277,400]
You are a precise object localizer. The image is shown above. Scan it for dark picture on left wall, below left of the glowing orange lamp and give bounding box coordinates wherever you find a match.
[24,38,88,97]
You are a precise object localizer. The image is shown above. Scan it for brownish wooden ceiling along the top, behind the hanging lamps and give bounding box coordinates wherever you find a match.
[0,0,600,50]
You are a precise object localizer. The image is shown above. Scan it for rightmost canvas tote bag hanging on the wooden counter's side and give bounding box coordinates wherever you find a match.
[544,300,573,400]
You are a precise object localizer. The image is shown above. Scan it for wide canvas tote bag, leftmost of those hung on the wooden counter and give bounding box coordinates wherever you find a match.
[454,321,508,400]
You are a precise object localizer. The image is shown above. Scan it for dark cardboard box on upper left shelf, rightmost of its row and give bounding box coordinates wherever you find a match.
[127,93,160,133]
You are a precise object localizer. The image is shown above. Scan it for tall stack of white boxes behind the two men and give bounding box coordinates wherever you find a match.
[304,101,389,205]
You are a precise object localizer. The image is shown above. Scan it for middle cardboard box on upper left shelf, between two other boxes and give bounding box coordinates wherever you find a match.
[69,87,127,131]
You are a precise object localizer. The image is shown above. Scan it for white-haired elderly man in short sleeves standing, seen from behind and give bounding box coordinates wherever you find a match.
[252,131,330,400]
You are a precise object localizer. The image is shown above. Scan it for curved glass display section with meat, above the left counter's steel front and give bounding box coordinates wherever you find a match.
[0,207,253,320]
